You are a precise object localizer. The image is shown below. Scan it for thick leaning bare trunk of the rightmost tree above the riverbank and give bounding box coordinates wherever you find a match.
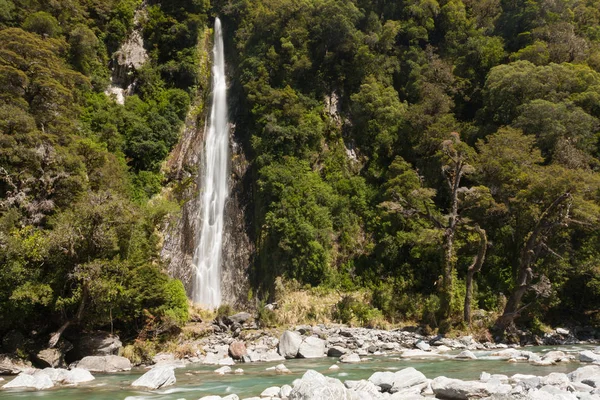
[495,192,571,334]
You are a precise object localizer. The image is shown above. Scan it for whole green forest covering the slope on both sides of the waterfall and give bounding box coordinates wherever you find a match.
[0,0,600,346]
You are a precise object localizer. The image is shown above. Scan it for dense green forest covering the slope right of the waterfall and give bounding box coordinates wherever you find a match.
[215,0,600,331]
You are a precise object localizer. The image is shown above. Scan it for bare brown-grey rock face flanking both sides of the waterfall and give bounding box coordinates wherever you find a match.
[161,28,253,307]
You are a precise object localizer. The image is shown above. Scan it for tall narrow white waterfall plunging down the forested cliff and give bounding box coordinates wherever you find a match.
[192,18,229,308]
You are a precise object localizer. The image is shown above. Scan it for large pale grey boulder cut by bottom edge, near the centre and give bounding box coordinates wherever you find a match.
[289,370,350,400]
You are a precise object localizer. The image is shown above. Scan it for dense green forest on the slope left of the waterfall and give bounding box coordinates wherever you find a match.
[0,0,208,340]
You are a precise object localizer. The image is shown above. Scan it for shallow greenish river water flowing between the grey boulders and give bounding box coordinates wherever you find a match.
[0,346,594,400]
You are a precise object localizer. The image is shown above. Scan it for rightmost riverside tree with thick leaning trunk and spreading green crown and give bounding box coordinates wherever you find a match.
[478,129,600,333]
